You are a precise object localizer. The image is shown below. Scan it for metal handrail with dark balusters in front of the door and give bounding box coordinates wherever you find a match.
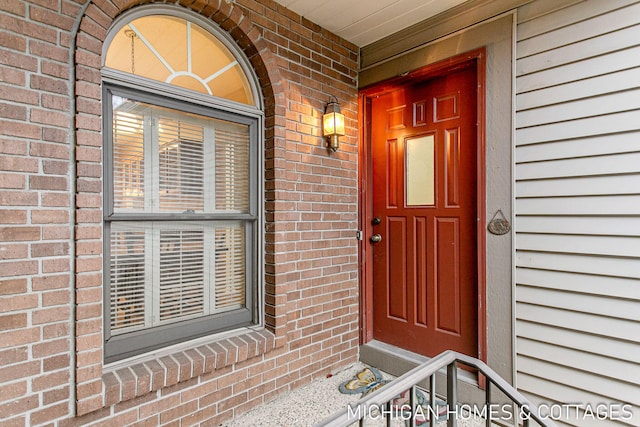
[316,350,555,427]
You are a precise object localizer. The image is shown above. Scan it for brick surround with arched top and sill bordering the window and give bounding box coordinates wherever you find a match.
[74,0,286,415]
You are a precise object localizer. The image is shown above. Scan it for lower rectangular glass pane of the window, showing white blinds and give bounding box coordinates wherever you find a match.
[109,221,246,335]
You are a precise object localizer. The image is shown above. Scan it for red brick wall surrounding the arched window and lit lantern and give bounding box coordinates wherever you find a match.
[0,0,358,426]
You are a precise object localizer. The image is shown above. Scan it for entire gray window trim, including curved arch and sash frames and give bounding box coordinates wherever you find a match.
[101,4,265,363]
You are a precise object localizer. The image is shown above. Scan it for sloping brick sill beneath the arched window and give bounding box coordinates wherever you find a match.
[98,329,276,415]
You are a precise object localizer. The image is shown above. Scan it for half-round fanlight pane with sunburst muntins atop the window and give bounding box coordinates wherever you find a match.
[105,15,255,105]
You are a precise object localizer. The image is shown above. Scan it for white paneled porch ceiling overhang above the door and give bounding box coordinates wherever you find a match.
[276,0,466,47]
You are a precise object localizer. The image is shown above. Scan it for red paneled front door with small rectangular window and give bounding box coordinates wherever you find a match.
[370,67,478,356]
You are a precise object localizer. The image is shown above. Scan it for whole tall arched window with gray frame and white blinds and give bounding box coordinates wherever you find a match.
[102,8,262,362]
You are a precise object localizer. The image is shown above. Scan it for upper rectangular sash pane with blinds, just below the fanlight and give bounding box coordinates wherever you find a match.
[112,97,250,214]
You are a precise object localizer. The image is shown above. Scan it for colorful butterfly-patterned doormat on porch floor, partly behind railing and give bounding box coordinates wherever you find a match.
[338,367,447,425]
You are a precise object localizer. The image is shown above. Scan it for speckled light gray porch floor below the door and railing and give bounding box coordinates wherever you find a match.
[221,363,485,427]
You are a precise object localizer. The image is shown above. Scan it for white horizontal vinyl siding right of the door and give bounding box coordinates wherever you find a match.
[514,0,640,426]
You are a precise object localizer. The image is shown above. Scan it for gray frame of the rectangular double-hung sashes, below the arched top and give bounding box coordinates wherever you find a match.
[102,83,263,363]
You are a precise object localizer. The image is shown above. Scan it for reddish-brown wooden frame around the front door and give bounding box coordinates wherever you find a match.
[358,47,487,362]
